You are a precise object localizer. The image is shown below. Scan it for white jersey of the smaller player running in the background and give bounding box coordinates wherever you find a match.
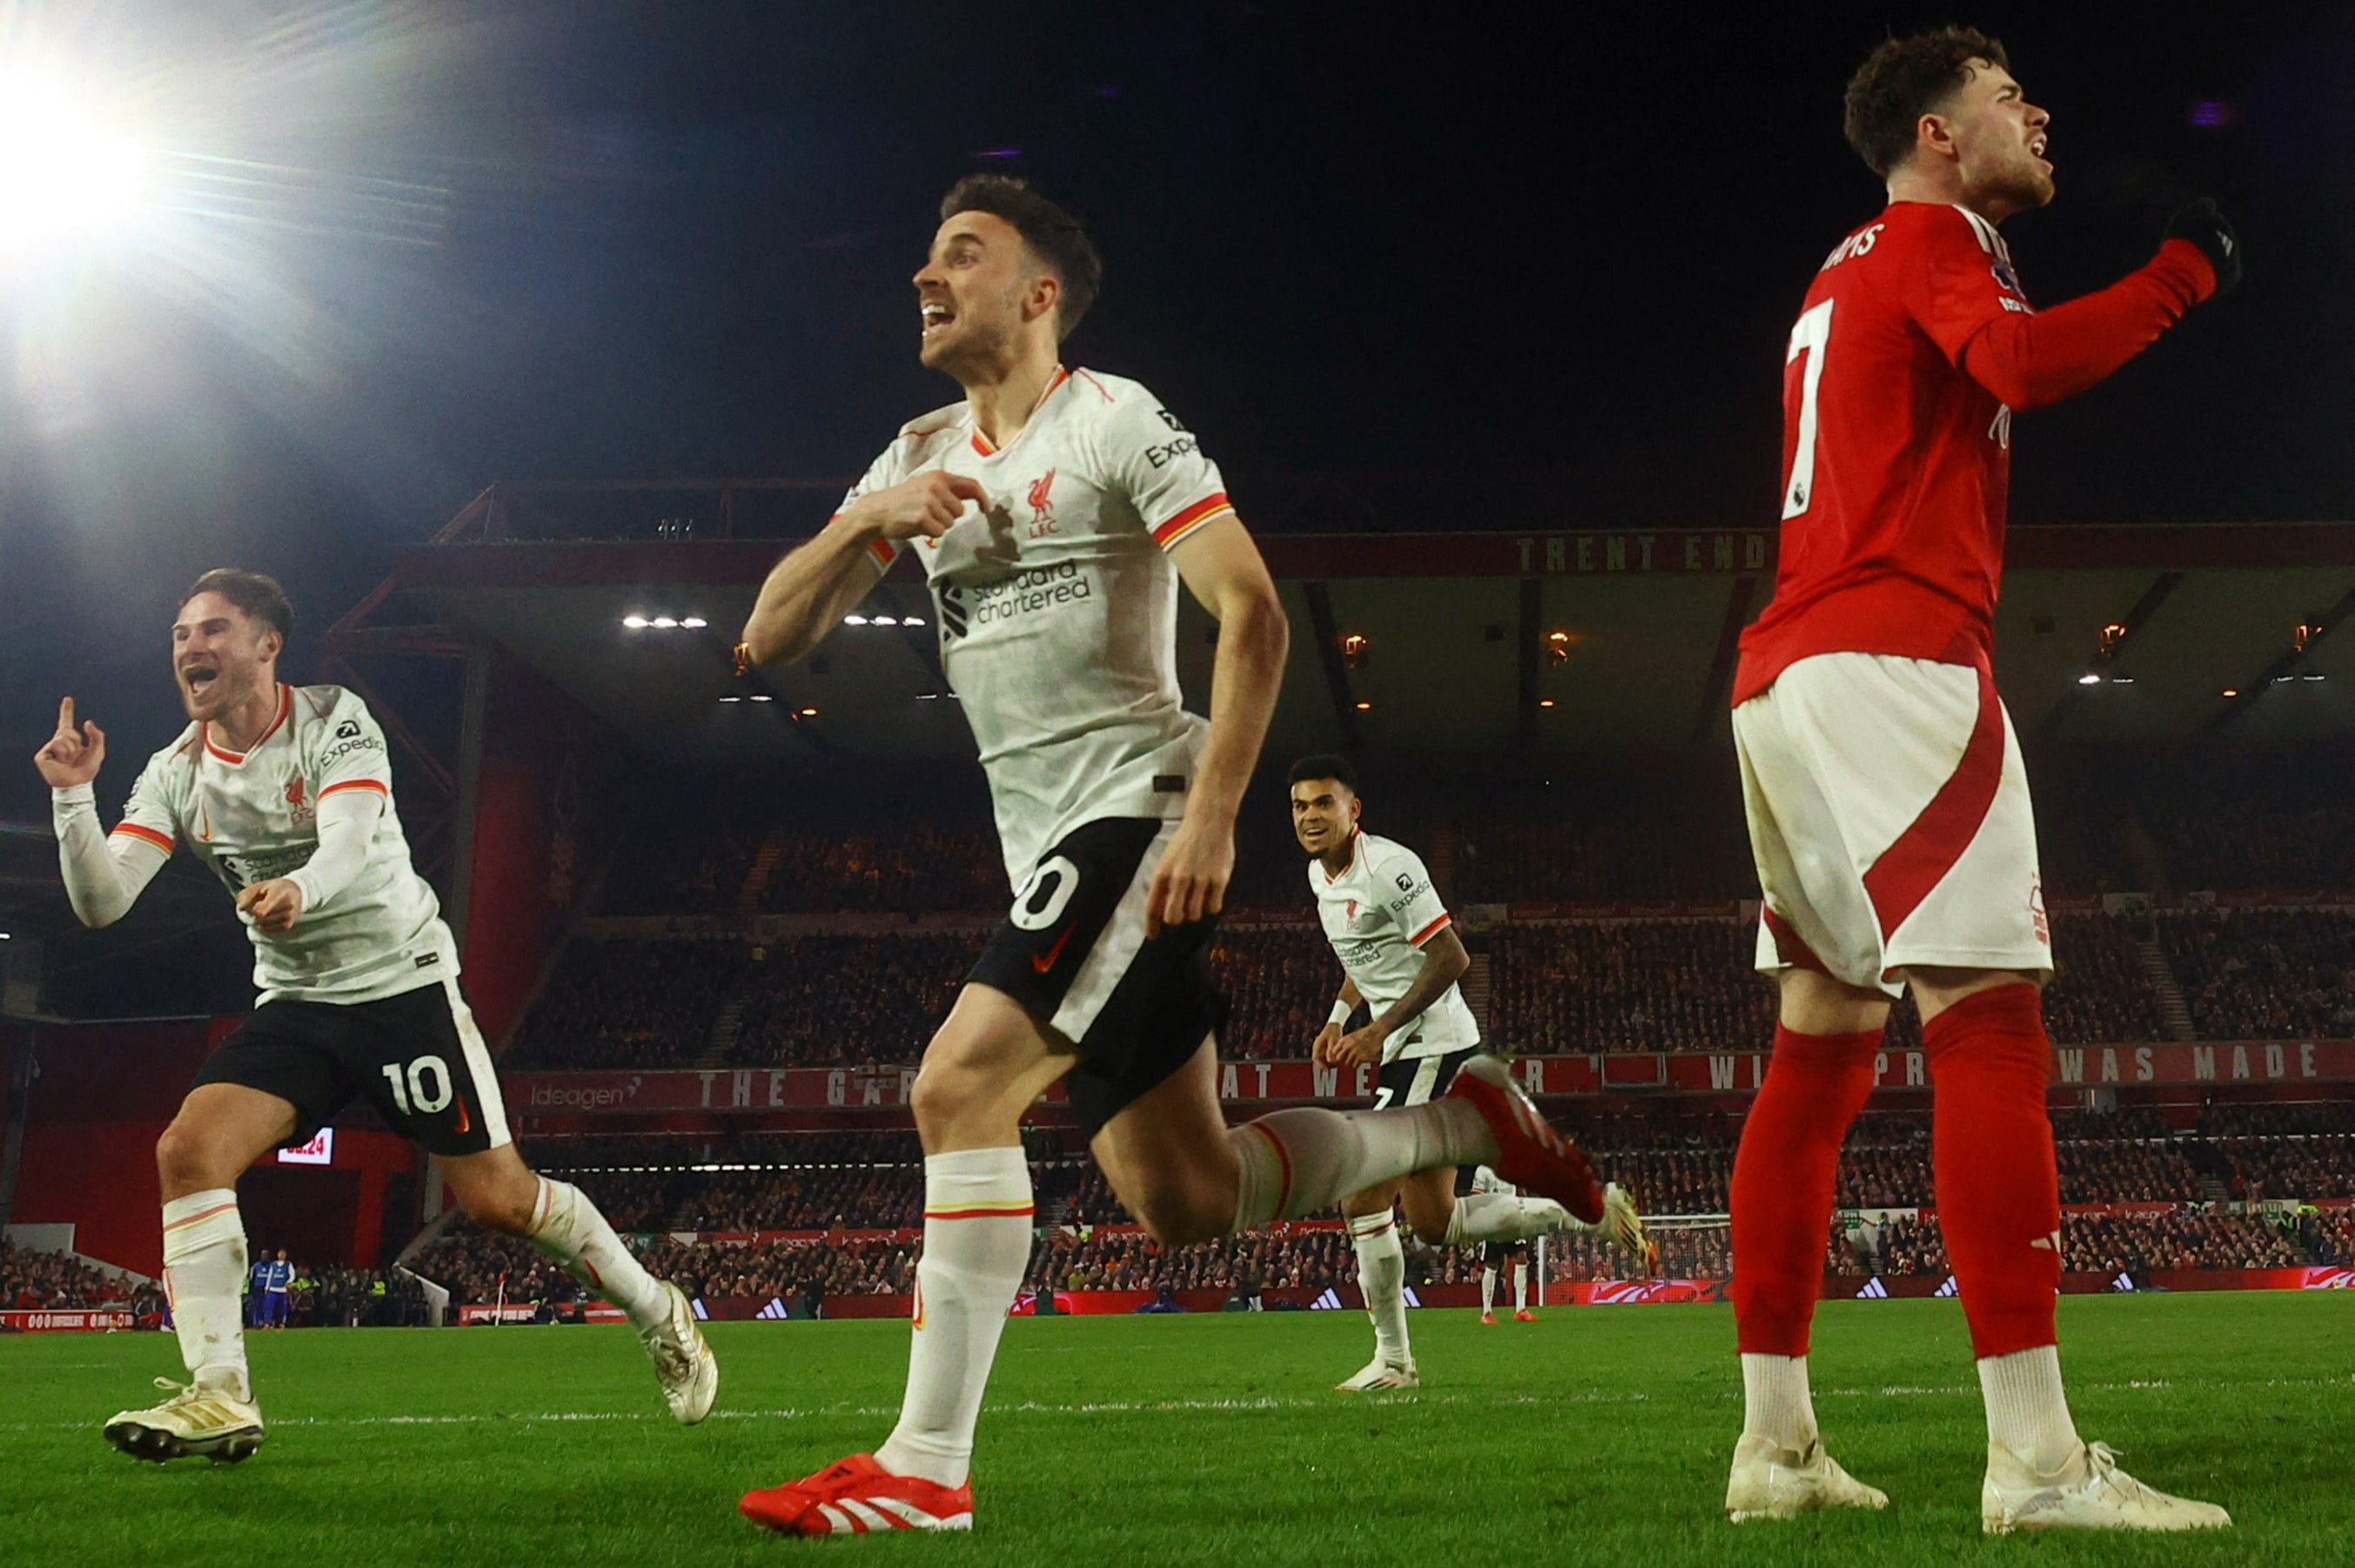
[1310,828,1479,1062]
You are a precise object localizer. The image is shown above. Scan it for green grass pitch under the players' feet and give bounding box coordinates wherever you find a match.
[0,1292,2355,1568]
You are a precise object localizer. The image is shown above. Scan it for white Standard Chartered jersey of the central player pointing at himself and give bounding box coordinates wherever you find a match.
[862,370,1234,888]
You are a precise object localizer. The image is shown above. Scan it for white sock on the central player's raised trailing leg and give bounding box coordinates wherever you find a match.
[1227,1100,1498,1231]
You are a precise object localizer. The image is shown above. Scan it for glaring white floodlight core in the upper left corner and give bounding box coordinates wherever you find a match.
[0,66,146,254]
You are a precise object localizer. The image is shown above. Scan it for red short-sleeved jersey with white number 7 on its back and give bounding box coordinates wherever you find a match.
[1734,203,2032,704]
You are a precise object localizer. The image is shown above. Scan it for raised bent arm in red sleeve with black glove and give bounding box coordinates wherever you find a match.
[1917,203,2239,410]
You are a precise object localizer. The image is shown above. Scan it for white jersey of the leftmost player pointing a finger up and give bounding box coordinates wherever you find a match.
[116,685,457,1003]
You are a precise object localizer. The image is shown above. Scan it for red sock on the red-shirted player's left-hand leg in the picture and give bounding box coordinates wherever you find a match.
[1734,1024,1882,1356]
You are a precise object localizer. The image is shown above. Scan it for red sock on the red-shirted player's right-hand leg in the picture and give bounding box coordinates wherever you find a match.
[1922,982,2061,1358]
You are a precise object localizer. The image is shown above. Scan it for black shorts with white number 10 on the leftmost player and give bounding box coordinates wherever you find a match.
[191,980,508,1154]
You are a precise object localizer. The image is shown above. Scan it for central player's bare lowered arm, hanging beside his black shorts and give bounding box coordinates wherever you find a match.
[1144,515,1293,935]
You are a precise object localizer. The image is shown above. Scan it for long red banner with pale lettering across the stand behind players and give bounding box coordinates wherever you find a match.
[504,1041,2355,1118]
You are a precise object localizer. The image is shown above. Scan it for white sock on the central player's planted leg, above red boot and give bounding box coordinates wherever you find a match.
[876,1147,1031,1485]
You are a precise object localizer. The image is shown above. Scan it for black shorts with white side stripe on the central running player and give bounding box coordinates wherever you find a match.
[965,817,1227,1137]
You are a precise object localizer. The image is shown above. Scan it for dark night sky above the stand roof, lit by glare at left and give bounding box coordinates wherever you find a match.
[0,3,2355,820]
